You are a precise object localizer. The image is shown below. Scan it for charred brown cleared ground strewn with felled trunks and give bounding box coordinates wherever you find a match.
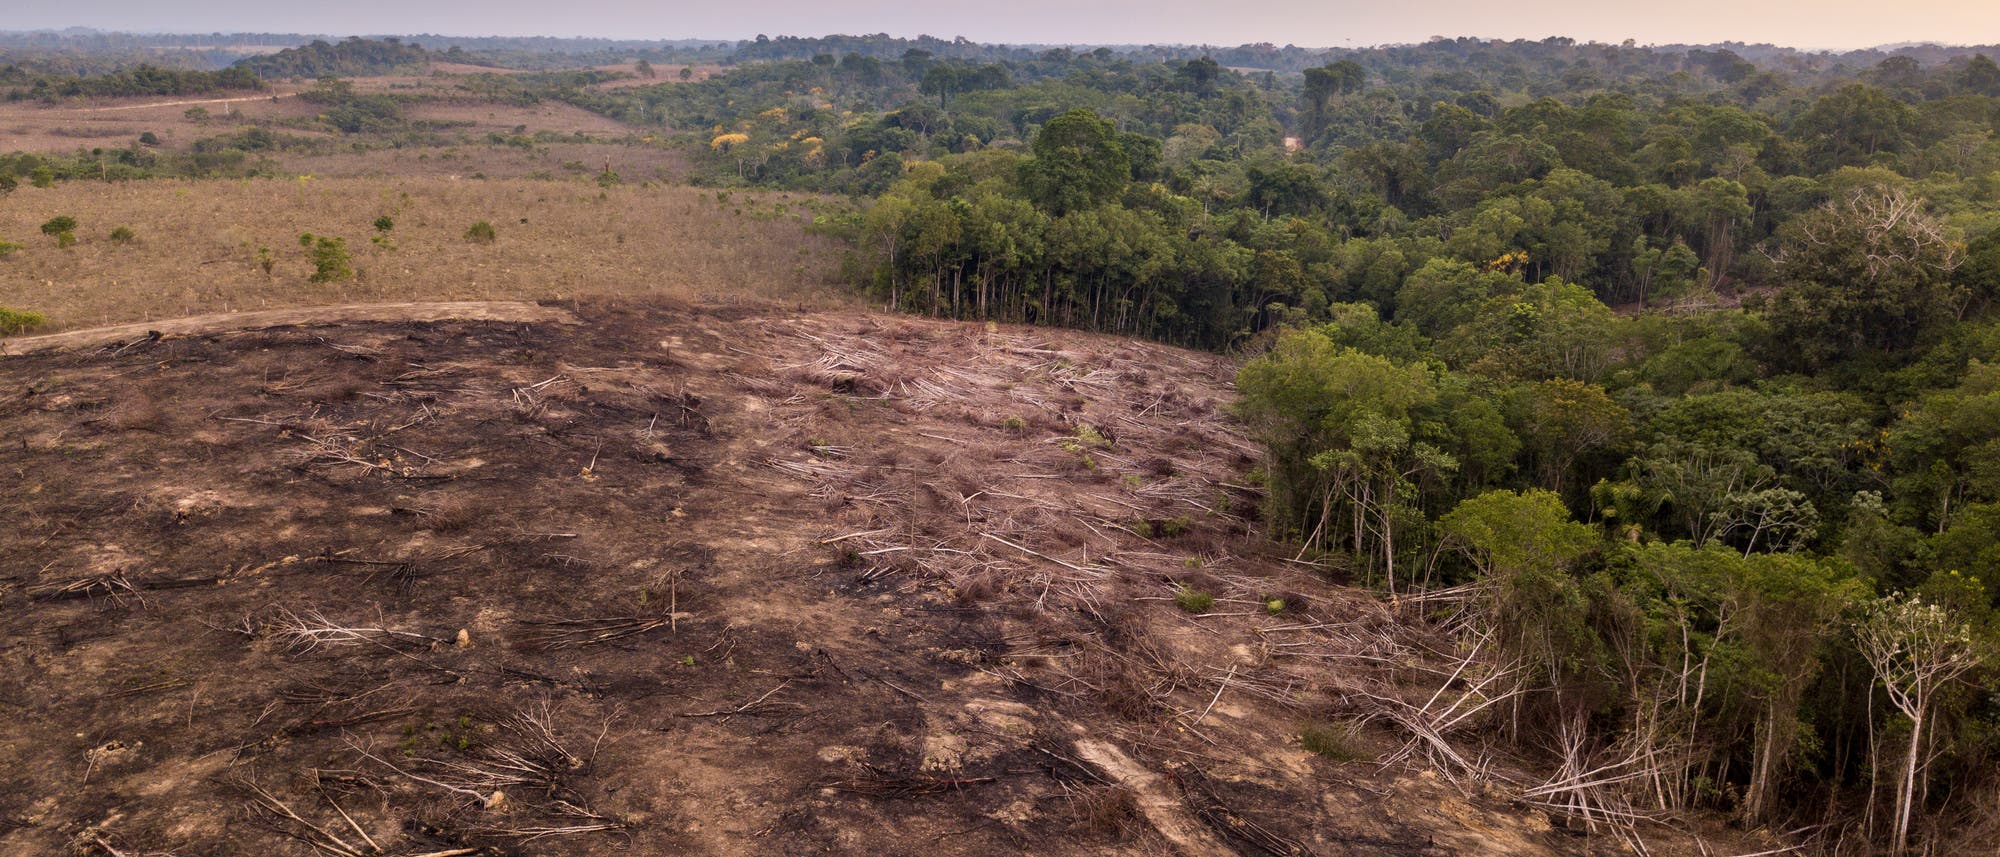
[0,304,1674,857]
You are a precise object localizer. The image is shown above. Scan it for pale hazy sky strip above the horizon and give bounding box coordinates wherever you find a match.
[15,0,2000,48]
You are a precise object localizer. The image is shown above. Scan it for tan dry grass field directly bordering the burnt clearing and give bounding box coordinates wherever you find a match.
[0,178,848,332]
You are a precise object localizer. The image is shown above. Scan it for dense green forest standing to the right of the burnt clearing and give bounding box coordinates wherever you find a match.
[564,33,2000,851]
